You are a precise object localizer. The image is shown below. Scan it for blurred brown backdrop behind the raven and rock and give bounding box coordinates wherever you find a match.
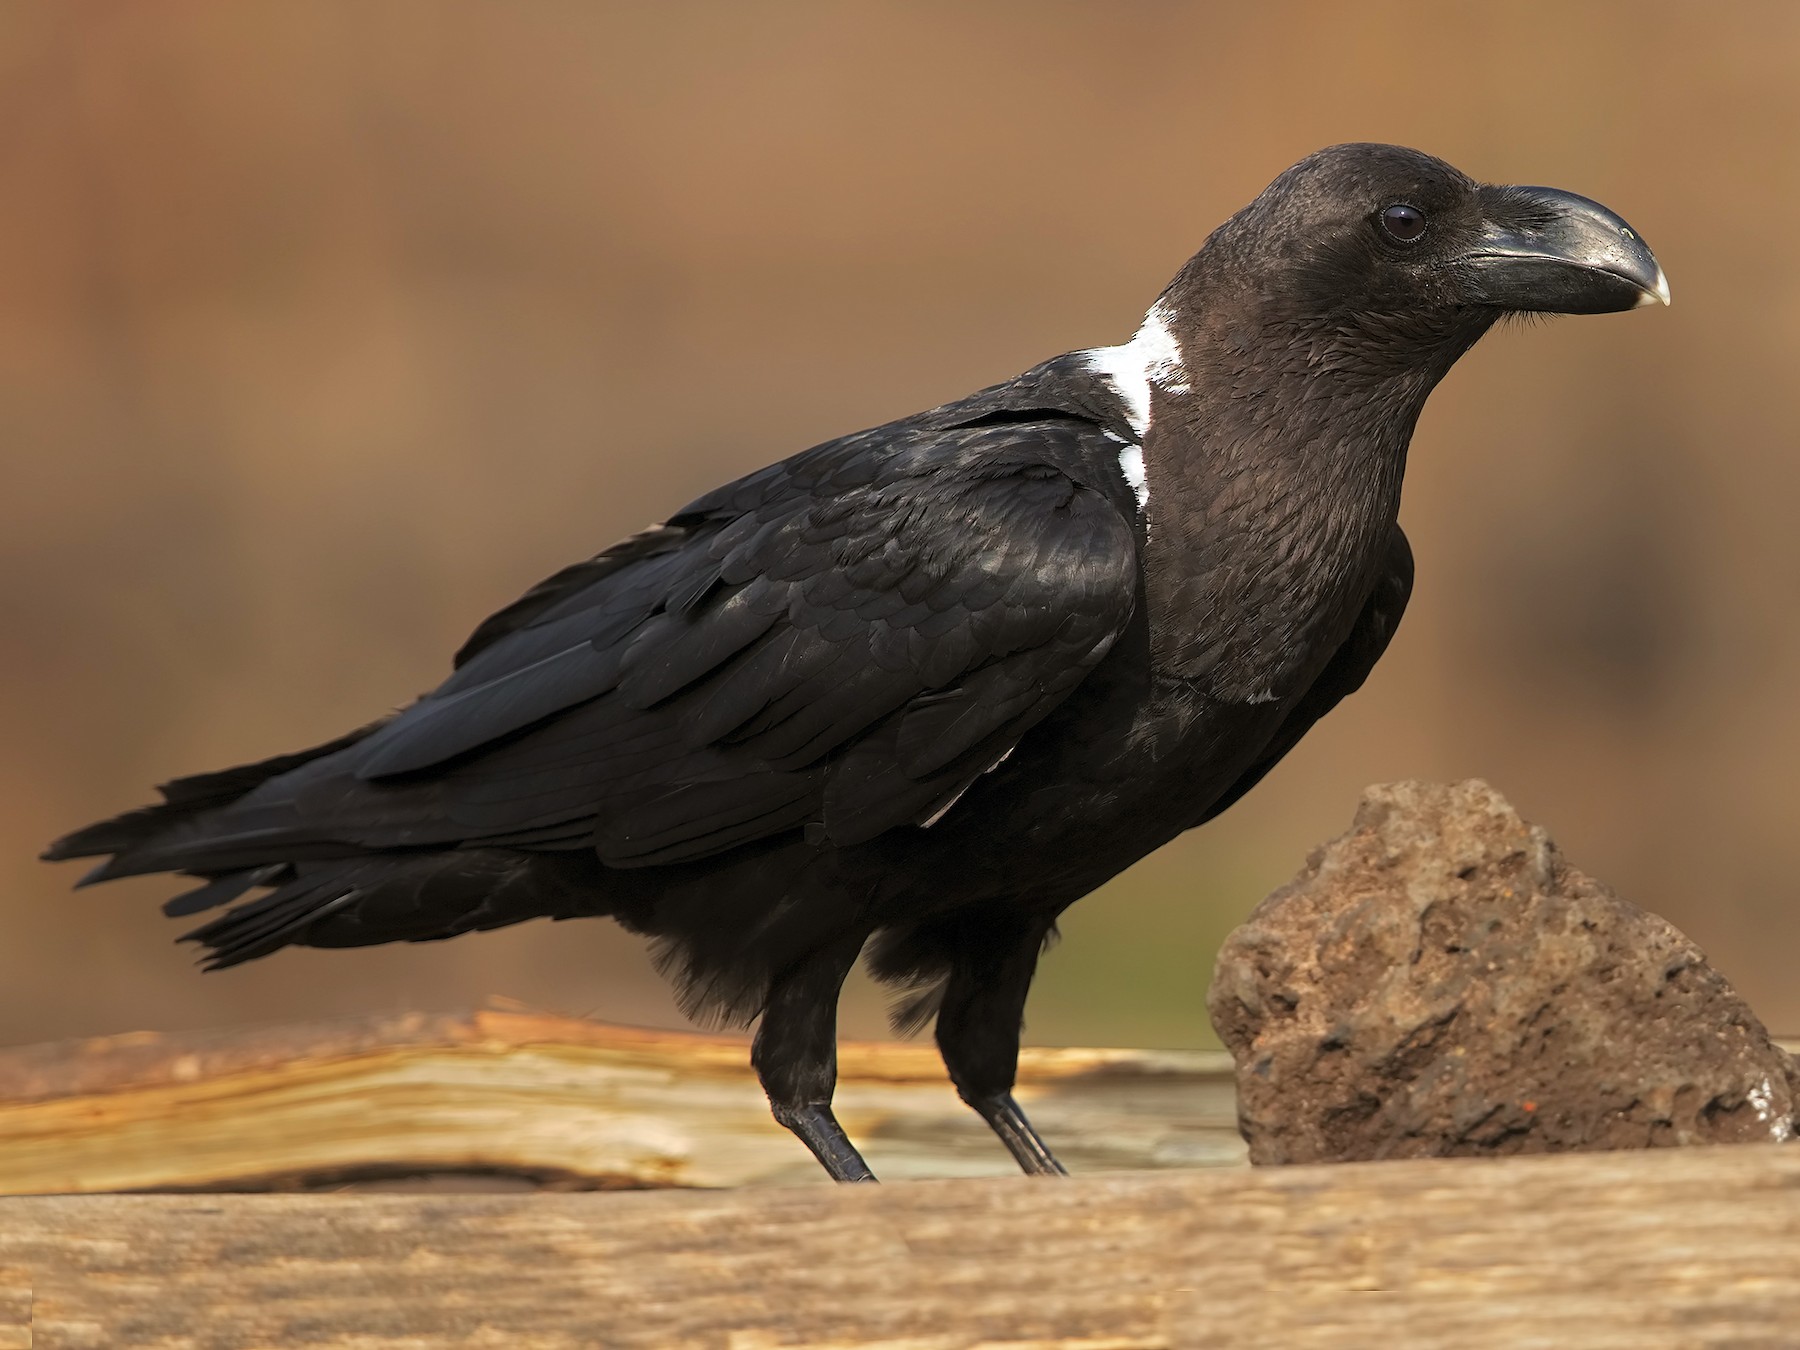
[0,0,1800,1046]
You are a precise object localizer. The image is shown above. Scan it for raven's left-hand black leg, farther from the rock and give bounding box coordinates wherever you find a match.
[751,936,875,1181]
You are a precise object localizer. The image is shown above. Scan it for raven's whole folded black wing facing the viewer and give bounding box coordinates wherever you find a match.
[91,412,1138,875]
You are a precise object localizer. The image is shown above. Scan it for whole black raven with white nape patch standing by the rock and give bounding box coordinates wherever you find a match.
[45,144,1669,1181]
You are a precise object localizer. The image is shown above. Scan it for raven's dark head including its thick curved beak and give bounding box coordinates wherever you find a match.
[1195,144,1669,331]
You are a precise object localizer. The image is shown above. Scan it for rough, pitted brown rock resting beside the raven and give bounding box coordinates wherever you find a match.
[1210,781,1800,1163]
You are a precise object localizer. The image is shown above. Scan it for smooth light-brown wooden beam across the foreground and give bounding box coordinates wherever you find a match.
[0,1145,1800,1350]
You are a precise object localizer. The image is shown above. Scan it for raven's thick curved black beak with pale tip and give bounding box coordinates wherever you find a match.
[1456,187,1669,313]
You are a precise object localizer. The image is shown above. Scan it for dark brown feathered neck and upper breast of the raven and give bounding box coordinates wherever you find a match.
[1143,302,1489,702]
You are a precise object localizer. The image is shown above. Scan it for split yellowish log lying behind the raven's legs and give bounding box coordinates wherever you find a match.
[0,1010,1244,1195]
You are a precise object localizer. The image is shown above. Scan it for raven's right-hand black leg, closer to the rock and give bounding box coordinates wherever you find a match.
[938,916,1067,1177]
